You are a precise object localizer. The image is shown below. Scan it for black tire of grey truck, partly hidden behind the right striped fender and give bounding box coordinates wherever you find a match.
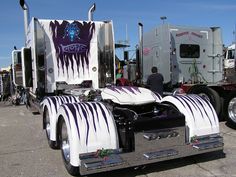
[189,86,222,119]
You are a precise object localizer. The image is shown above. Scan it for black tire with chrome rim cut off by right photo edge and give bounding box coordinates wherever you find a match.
[224,92,236,128]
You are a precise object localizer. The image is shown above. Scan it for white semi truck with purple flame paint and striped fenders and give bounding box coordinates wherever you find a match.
[13,0,223,175]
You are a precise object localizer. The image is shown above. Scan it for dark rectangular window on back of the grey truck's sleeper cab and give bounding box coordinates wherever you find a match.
[179,44,200,58]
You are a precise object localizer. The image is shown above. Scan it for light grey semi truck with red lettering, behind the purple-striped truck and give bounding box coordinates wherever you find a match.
[141,24,236,126]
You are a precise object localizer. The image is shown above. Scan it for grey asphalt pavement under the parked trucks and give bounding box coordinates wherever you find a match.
[0,102,236,177]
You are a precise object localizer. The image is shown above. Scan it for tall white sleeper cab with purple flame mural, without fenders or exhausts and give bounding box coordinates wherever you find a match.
[22,18,115,93]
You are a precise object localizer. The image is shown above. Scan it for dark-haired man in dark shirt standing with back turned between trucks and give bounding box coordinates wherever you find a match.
[147,66,164,95]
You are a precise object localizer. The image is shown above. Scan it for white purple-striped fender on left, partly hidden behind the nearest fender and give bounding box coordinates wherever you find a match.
[40,95,79,141]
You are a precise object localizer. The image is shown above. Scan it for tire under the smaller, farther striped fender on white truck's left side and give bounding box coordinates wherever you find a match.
[43,107,59,149]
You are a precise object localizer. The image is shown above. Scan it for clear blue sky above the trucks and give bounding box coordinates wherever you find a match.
[0,0,236,68]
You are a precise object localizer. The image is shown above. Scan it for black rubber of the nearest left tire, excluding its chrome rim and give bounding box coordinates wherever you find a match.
[58,117,80,176]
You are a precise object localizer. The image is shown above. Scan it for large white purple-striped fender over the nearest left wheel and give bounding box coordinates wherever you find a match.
[57,102,119,167]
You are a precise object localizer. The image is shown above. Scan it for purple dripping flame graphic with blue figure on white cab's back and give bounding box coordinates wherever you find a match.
[50,20,95,75]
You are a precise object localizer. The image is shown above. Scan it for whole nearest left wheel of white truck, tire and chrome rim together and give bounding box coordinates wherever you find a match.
[59,117,80,176]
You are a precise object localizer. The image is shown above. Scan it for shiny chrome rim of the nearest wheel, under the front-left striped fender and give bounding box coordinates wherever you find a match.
[61,121,70,162]
